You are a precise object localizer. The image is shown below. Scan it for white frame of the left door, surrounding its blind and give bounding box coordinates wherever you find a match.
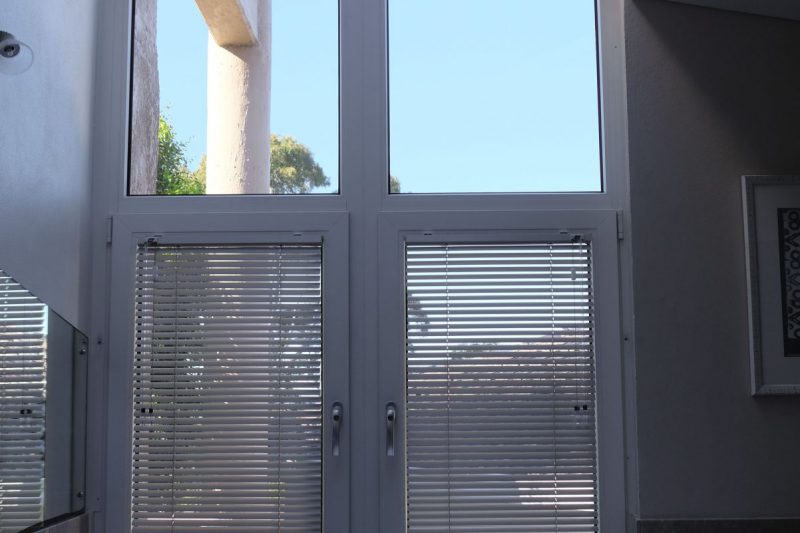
[105,213,350,532]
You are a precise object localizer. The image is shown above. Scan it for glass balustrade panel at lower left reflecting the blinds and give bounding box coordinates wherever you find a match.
[0,271,86,533]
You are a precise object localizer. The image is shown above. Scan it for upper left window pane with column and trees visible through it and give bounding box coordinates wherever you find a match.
[128,0,339,195]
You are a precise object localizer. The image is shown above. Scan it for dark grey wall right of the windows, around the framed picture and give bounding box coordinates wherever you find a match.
[625,0,800,518]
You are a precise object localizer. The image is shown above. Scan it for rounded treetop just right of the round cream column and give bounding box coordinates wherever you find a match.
[269,133,330,194]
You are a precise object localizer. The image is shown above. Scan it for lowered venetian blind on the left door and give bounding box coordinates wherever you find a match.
[131,245,322,533]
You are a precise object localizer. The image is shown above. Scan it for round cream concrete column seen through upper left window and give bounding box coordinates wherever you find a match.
[205,0,272,194]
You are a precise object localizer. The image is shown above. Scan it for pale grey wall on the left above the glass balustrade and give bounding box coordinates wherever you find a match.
[0,0,96,330]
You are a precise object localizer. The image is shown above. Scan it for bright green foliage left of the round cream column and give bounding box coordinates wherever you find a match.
[156,116,206,195]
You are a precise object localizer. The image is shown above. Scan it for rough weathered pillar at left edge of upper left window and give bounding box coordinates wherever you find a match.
[130,1,160,194]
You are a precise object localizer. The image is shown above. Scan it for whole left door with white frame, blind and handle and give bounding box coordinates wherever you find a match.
[102,214,350,533]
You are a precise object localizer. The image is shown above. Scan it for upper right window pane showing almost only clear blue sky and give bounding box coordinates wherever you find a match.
[389,0,602,193]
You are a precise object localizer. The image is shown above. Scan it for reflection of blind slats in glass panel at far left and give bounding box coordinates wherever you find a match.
[0,271,47,533]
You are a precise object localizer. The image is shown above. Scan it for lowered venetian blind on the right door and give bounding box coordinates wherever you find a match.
[406,242,597,533]
